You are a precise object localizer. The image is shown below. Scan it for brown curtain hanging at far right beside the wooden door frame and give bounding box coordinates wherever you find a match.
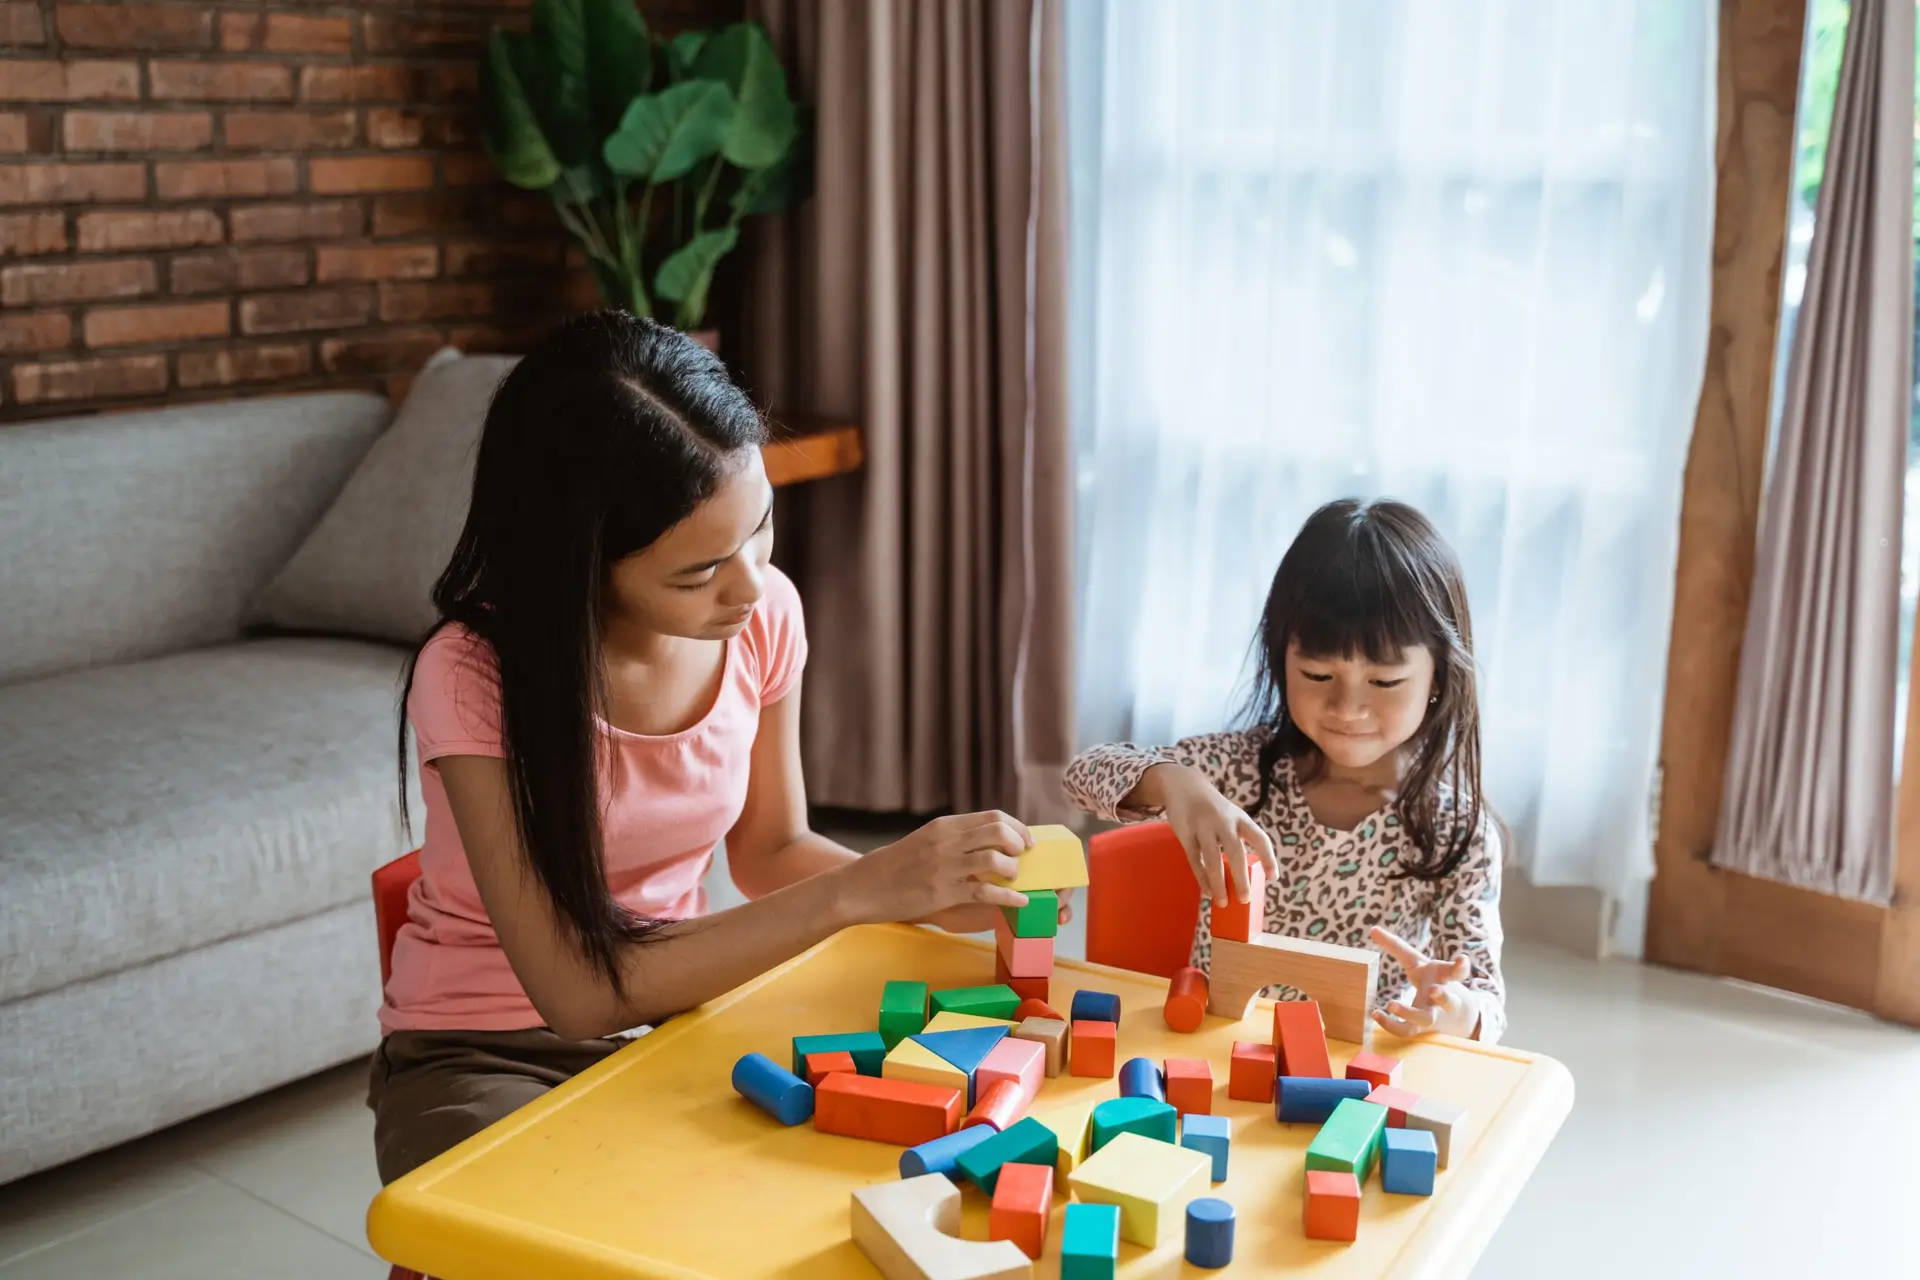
[1713,0,1914,902]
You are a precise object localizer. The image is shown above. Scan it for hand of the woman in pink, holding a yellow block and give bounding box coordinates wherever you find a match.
[833,812,1033,929]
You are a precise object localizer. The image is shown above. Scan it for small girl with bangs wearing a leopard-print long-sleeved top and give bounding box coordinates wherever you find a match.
[1066,501,1507,1040]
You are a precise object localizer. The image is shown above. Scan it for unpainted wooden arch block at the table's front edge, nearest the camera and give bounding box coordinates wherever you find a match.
[852,1173,1033,1280]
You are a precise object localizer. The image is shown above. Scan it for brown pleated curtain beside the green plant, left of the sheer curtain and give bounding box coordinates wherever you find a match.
[737,0,1073,819]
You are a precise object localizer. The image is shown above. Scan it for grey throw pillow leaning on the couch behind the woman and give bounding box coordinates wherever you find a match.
[252,349,516,643]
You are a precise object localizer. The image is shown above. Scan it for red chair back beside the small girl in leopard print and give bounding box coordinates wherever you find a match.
[1087,821,1200,977]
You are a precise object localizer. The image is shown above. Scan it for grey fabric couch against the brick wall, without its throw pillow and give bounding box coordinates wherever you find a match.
[0,393,418,1182]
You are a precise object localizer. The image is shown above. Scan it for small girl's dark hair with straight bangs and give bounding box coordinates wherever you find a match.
[1246,499,1480,881]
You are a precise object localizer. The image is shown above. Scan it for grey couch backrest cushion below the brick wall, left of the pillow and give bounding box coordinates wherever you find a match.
[0,391,390,681]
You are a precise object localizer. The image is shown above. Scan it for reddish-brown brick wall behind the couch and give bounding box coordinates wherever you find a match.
[0,0,739,420]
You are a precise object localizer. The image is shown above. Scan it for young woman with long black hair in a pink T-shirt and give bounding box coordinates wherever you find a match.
[369,311,1031,1182]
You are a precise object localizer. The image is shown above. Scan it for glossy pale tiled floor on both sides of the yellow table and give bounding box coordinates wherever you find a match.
[0,898,1920,1280]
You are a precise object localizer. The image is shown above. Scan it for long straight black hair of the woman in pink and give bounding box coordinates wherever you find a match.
[399,311,766,988]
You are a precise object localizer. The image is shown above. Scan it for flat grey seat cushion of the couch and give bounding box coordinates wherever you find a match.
[0,639,419,1000]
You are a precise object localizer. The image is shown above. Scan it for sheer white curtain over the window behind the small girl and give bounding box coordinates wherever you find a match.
[1068,0,1720,946]
